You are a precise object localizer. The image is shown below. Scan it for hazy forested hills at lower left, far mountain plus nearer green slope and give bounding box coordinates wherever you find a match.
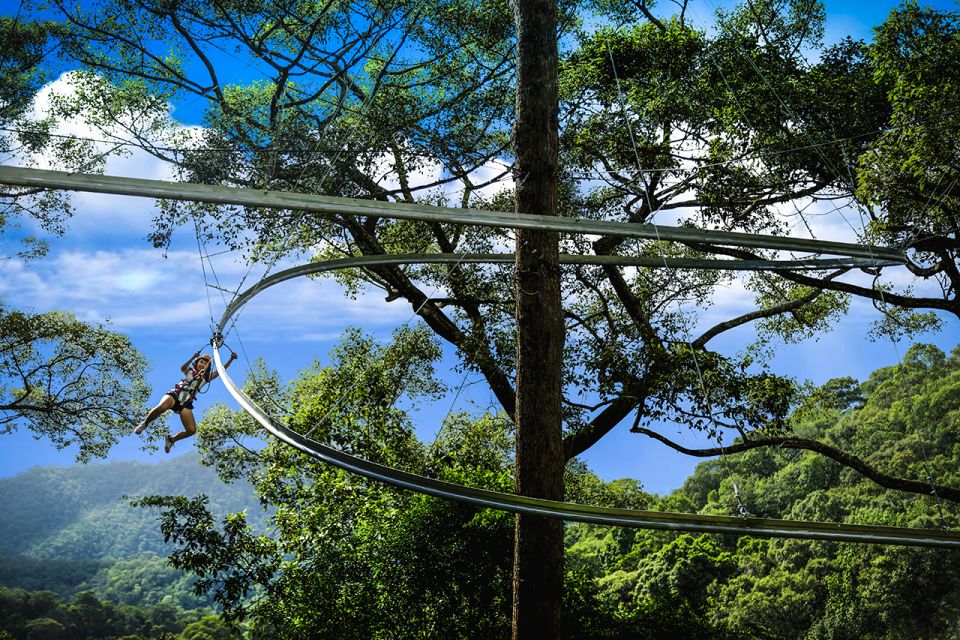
[0,453,265,609]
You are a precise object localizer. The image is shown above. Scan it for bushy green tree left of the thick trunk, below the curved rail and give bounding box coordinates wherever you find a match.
[141,330,512,638]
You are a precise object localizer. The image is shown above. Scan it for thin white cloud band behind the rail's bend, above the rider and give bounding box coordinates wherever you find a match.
[0,249,412,340]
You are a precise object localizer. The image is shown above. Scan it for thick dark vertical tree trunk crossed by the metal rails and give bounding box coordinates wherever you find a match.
[513,0,564,640]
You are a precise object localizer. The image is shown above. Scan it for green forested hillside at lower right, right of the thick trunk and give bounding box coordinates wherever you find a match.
[567,346,960,640]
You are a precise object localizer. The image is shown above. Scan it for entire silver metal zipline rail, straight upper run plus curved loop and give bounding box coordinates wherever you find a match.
[0,166,944,549]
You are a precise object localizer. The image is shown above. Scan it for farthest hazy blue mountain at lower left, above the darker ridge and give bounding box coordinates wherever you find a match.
[0,453,265,561]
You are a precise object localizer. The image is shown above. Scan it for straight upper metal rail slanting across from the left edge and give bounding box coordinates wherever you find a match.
[0,166,907,266]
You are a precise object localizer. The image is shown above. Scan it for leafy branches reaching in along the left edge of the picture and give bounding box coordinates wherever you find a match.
[0,12,149,461]
